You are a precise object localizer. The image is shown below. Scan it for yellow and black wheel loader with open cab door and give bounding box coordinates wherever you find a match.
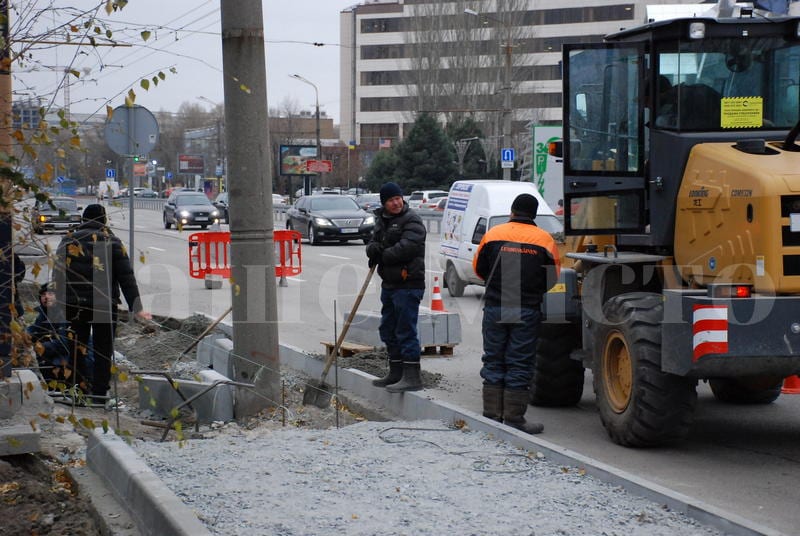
[531,2,800,447]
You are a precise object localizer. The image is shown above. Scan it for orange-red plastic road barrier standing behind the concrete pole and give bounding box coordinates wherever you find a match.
[189,230,302,279]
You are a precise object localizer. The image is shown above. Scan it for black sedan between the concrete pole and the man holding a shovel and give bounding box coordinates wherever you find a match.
[286,195,375,245]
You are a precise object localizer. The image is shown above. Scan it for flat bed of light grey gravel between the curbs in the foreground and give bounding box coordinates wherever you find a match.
[133,421,720,536]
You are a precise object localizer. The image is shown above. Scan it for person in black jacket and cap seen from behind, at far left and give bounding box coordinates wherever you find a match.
[55,204,151,402]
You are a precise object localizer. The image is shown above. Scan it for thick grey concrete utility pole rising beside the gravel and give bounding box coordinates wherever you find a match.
[220,0,280,419]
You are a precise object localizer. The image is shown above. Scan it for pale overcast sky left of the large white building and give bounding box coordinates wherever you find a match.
[12,0,359,123]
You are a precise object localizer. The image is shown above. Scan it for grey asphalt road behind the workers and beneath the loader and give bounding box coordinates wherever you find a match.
[21,201,800,534]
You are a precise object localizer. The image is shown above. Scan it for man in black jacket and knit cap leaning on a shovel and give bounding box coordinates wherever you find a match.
[367,182,426,393]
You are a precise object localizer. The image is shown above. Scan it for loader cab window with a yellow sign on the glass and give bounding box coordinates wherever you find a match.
[654,36,800,131]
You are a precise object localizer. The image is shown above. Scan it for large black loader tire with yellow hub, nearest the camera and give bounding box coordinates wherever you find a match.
[593,292,697,447]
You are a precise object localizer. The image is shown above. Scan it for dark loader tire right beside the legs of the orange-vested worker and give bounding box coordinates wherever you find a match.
[530,323,583,407]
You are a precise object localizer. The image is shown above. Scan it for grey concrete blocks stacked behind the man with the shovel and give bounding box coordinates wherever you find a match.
[344,307,461,348]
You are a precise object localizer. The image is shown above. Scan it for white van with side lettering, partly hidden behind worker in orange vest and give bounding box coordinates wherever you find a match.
[439,180,564,298]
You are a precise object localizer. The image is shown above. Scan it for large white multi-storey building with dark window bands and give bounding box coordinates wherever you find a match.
[340,0,715,149]
